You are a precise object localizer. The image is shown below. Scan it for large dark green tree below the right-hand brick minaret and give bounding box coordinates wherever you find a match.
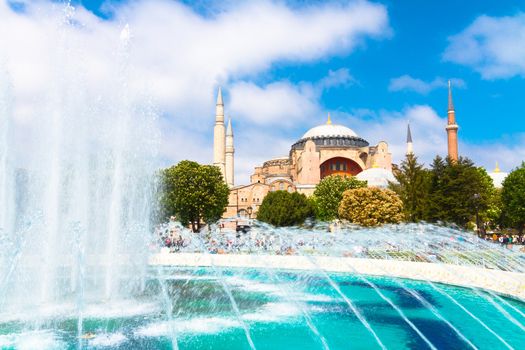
[428,156,495,227]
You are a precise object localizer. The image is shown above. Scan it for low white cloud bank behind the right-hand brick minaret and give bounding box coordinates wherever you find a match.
[335,105,525,172]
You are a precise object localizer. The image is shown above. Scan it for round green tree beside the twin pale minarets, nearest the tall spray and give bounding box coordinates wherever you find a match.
[160,160,229,232]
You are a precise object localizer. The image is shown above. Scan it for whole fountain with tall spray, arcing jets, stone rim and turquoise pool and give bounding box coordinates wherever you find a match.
[0,4,525,349]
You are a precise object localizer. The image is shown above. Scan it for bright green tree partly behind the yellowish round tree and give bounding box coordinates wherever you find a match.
[311,175,366,221]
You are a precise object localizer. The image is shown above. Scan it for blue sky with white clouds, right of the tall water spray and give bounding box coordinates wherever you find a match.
[4,0,525,182]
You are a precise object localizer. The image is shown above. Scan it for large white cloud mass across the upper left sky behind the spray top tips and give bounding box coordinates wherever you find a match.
[0,0,390,185]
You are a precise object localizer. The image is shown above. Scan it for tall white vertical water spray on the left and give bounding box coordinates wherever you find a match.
[0,5,160,318]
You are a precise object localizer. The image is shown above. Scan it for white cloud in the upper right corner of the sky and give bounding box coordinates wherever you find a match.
[443,13,525,79]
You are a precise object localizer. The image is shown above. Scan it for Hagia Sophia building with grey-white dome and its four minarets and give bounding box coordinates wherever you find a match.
[213,82,506,218]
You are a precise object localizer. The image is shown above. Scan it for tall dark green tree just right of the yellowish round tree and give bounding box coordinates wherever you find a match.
[389,154,430,222]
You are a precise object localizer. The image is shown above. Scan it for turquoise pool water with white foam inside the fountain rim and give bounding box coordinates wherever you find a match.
[0,268,525,350]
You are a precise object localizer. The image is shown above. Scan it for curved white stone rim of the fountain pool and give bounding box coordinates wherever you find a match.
[149,253,525,301]
